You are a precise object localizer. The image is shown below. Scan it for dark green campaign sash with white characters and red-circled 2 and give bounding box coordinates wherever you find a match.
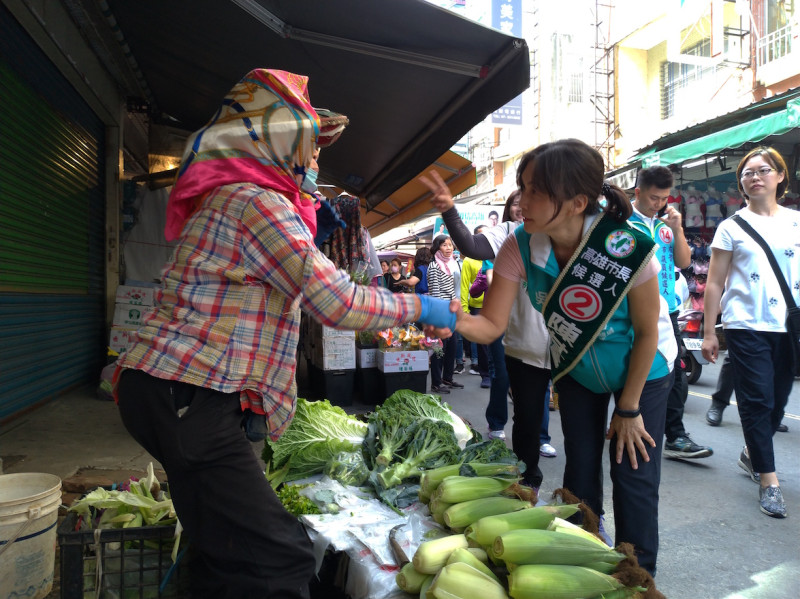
[542,214,655,382]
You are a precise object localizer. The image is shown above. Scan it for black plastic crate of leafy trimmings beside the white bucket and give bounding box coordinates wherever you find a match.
[58,512,189,599]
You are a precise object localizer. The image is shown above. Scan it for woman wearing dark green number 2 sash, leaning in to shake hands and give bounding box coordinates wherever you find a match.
[444,139,677,575]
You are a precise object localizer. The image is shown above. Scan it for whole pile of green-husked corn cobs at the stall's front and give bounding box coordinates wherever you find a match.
[395,474,655,599]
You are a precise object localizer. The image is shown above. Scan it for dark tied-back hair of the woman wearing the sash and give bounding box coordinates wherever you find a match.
[517,139,633,222]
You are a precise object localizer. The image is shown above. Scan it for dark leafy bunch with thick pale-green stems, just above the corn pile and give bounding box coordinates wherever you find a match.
[377,419,459,489]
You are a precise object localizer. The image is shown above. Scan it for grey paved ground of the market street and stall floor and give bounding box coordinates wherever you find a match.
[0,354,800,599]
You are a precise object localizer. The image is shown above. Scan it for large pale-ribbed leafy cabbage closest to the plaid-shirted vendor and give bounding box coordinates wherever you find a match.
[262,397,367,481]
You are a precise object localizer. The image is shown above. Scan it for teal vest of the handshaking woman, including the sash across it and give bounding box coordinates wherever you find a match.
[515,215,655,393]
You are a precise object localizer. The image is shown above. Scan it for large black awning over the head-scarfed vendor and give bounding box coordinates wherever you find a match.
[107,0,530,209]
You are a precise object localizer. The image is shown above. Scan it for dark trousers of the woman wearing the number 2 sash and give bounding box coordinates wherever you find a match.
[556,374,672,575]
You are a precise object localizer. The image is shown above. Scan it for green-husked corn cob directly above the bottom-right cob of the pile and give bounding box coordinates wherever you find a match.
[491,529,625,566]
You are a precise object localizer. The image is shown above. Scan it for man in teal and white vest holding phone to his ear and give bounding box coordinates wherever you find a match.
[628,166,714,458]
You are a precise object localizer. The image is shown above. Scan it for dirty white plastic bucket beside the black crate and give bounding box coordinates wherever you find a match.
[0,472,61,599]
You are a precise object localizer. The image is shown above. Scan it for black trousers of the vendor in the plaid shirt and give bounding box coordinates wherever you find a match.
[118,370,315,599]
